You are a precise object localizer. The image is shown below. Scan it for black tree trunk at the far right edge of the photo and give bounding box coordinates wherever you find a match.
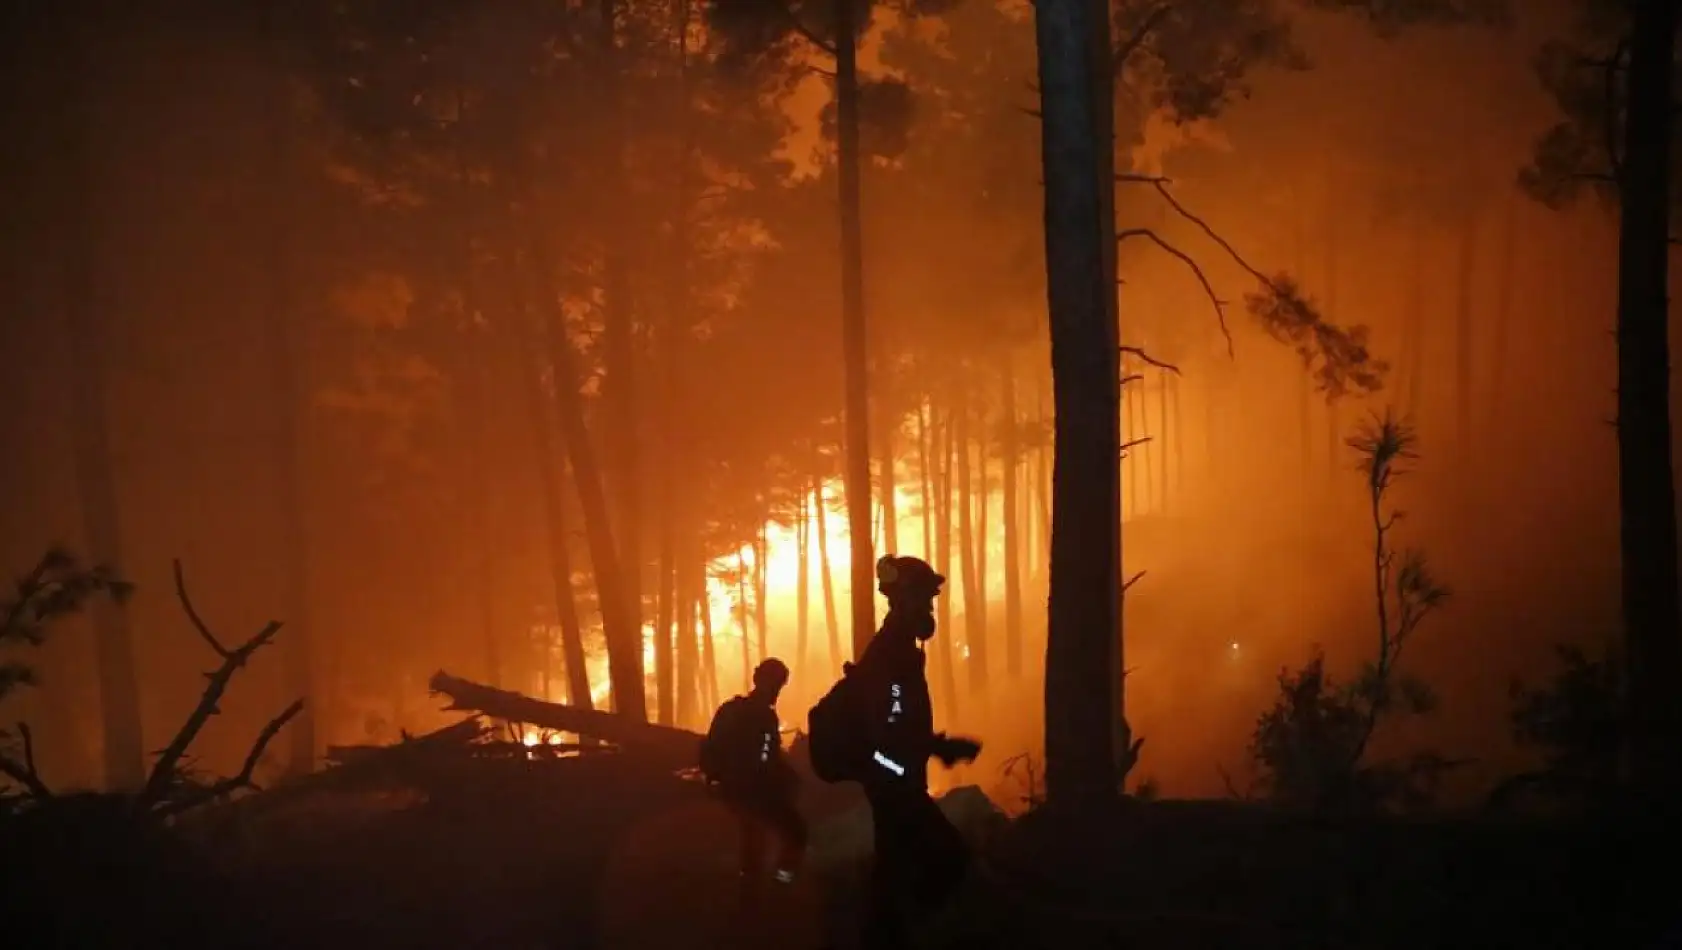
[1618,0,1682,809]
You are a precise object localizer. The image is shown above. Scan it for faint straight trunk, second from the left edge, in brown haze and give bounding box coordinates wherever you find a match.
[262,0,318,775]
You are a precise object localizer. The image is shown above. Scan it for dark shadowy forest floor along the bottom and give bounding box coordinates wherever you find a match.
[0,755,1682,950]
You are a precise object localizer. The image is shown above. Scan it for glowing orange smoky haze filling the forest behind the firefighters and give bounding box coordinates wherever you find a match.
[0,2,1641,800]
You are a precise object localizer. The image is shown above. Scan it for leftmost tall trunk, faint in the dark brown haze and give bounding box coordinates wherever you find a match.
[64,17,146,792]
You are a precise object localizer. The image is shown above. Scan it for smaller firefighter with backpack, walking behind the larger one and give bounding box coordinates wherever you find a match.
[701,659,806,886]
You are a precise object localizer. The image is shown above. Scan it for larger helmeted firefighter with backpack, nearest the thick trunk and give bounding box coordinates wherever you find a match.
[809,555,981,948]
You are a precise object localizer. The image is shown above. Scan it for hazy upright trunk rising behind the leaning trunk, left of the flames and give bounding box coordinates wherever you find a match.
[595,0,648,689]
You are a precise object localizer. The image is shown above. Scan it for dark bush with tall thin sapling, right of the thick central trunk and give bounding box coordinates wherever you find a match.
[1250,412,1458,810]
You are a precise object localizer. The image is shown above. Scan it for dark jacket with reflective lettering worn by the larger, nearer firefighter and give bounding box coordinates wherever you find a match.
[854,610,935,789]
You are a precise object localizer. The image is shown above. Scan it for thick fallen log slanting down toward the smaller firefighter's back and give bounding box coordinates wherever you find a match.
[427,671,701,772]
